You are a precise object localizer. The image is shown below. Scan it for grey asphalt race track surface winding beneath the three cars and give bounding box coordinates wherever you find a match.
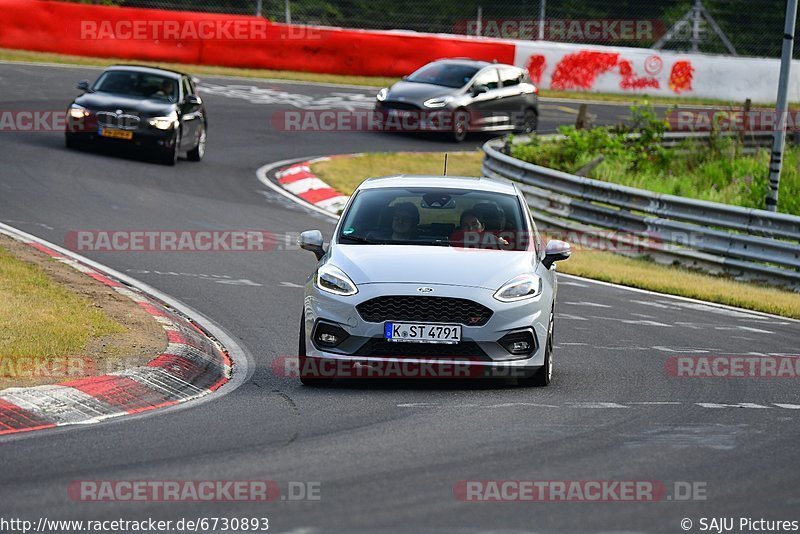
[0,64,800,532]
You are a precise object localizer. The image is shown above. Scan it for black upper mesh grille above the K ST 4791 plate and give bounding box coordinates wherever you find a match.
[356,296,492,326]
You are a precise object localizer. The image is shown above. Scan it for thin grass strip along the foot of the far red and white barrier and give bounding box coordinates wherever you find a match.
[0,48,800,109]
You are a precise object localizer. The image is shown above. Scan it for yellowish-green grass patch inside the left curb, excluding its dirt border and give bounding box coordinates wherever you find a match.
[0,248,125,361]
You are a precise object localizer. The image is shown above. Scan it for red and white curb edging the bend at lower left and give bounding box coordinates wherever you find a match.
[0,225,241,435]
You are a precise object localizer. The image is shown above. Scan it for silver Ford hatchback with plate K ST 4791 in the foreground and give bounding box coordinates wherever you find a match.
[299,176,570,386]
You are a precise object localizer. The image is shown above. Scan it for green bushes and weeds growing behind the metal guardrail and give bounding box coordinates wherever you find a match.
[511,106,800,215]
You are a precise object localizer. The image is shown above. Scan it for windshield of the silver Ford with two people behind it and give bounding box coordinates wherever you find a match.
[338,187,529,250]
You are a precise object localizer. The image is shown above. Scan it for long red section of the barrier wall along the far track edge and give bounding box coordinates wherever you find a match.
[0,0,515,76]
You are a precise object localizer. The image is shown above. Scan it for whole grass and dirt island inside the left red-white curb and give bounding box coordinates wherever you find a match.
[0,235,166,389]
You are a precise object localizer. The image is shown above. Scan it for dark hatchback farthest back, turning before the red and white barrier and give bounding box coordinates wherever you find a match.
[375,59,539,142]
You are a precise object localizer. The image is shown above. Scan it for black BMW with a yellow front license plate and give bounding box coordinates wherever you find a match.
[66,65,208,165]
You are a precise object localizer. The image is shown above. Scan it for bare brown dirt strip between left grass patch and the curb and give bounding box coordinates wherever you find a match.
[0,235,167,390]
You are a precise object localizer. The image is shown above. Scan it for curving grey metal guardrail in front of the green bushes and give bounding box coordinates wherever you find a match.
[482,133,800,290]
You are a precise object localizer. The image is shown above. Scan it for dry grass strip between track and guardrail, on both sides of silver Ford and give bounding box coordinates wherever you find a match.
[312,151,800,319]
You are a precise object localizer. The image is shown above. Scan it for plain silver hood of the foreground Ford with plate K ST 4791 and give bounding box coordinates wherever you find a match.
[329,244,535,290]
